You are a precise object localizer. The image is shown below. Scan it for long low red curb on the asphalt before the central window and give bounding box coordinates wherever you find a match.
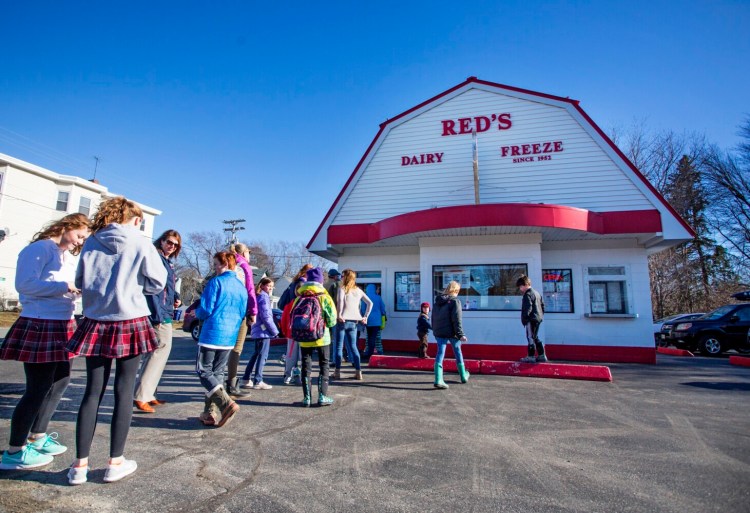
[369,355,612,382]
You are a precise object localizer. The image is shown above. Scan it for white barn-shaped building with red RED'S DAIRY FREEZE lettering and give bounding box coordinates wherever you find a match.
[308,77,694,363]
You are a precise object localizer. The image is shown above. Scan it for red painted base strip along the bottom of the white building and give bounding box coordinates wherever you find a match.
[383,339,656,364]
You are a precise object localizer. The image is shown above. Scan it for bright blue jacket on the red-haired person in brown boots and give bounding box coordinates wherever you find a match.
[195,271,247,349]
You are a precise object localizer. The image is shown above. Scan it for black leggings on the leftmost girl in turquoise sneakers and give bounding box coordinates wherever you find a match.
[9,362,70,447]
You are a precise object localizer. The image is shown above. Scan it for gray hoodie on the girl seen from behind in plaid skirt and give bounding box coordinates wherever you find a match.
[76,223,167,321]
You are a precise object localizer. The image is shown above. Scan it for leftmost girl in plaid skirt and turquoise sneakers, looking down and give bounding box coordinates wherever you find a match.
[0,214,91,470]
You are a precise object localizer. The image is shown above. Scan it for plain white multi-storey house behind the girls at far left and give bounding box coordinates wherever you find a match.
[0,153,161,299]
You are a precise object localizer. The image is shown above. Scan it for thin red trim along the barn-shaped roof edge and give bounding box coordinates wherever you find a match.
[307,77,695,249]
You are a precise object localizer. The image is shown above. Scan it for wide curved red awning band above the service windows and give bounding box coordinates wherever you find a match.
[328,203,661,244]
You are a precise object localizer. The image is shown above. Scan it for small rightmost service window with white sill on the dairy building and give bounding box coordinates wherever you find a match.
[584,266,633,317]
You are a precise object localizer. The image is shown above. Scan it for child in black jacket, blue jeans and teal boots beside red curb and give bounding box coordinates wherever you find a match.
[432,281,469,389]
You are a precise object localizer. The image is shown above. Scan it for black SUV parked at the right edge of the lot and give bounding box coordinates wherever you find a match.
[671,304,750,356]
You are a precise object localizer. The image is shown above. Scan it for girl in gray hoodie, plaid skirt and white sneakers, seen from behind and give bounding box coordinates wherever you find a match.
[68,197,167,485]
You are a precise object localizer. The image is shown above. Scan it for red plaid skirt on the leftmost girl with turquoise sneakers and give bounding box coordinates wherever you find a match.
[0,317,76,363]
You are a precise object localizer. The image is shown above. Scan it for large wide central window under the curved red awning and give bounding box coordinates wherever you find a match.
[432,264,528,311]
